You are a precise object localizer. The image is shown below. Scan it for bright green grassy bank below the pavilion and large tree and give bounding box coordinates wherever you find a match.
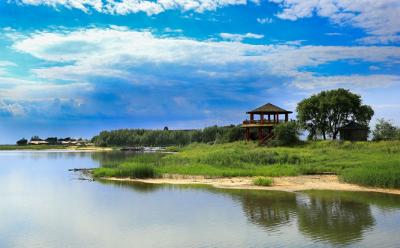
[94,141,400,188]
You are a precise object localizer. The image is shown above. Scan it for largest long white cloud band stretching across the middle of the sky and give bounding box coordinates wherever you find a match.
[8,27,400,89]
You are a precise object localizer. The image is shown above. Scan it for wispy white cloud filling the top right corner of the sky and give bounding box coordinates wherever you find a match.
[270,0,400,44]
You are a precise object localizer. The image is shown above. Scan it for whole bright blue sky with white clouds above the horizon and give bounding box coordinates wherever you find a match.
[0,0,400,143]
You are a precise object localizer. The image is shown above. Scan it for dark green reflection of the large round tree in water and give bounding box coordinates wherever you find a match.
[297,191,375,245]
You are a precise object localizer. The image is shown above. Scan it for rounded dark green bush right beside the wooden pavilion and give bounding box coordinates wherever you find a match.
[273,121,300,146]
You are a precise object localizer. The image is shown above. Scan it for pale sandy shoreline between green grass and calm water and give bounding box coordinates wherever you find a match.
[102,175,400,195]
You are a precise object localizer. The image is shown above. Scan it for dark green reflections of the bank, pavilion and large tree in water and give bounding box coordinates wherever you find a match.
[97,178,394,245]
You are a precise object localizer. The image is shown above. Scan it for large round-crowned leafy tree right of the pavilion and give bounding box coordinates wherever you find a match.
[297,89,374,139]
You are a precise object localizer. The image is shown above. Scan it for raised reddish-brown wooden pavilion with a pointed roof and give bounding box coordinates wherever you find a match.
[242,103,293,144]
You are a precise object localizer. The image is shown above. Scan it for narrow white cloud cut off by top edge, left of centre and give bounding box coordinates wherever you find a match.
[14,0,259,15]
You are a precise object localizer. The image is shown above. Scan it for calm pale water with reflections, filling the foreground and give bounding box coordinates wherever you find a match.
[0,152,400,248]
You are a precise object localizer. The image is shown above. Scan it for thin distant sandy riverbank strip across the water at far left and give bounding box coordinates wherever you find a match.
[0,145,113,152]
